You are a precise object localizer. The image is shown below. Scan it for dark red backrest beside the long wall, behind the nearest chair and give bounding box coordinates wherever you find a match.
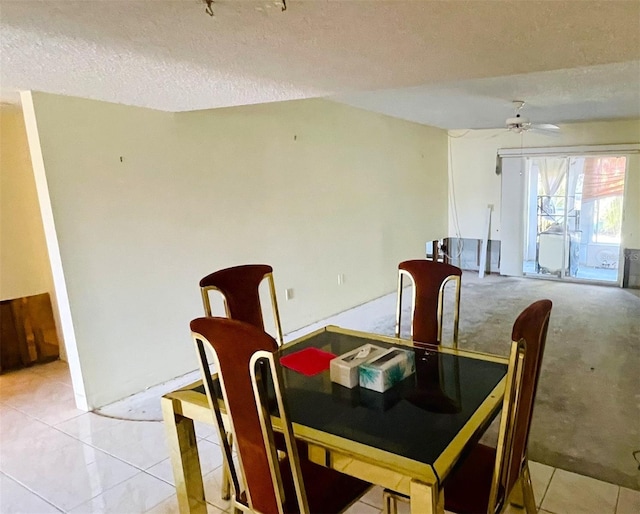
[200,264,283,344]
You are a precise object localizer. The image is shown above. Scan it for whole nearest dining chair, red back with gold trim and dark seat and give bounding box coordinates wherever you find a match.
[191,318,371,514]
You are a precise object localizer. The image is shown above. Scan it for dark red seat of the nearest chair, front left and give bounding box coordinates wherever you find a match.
[280,455,371,514]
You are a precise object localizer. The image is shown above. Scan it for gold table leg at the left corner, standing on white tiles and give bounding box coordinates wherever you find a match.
[161,398,207,508]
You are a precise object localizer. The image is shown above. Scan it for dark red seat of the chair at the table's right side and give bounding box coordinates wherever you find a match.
[444,444,496,514]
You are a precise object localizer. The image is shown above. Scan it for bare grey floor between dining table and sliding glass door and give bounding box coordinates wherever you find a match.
[318,272,640,490]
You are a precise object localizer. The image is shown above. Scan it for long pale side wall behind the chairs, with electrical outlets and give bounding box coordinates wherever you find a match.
[25,93,447,407]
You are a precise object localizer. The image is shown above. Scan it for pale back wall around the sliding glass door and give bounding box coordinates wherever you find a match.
[449,120,640,248]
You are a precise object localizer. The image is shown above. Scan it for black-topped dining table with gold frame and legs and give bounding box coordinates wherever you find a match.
[161,326,508,514]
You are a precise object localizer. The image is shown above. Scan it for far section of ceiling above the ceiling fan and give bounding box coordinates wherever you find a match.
[333,61,640,129]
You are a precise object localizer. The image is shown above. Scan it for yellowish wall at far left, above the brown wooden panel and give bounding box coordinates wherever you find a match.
[0,106,53,300]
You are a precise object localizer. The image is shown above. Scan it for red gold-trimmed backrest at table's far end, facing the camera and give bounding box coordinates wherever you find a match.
[396,259,462,346]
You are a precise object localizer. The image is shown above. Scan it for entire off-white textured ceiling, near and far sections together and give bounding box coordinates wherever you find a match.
[0,0,640,128]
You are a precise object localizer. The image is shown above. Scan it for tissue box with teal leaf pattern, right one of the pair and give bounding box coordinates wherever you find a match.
[358,348,416,393]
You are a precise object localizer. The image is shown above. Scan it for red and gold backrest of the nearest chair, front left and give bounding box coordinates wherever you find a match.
[191,317,306,514]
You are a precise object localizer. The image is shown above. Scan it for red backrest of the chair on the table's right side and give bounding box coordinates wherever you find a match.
[489,300,552,512]
